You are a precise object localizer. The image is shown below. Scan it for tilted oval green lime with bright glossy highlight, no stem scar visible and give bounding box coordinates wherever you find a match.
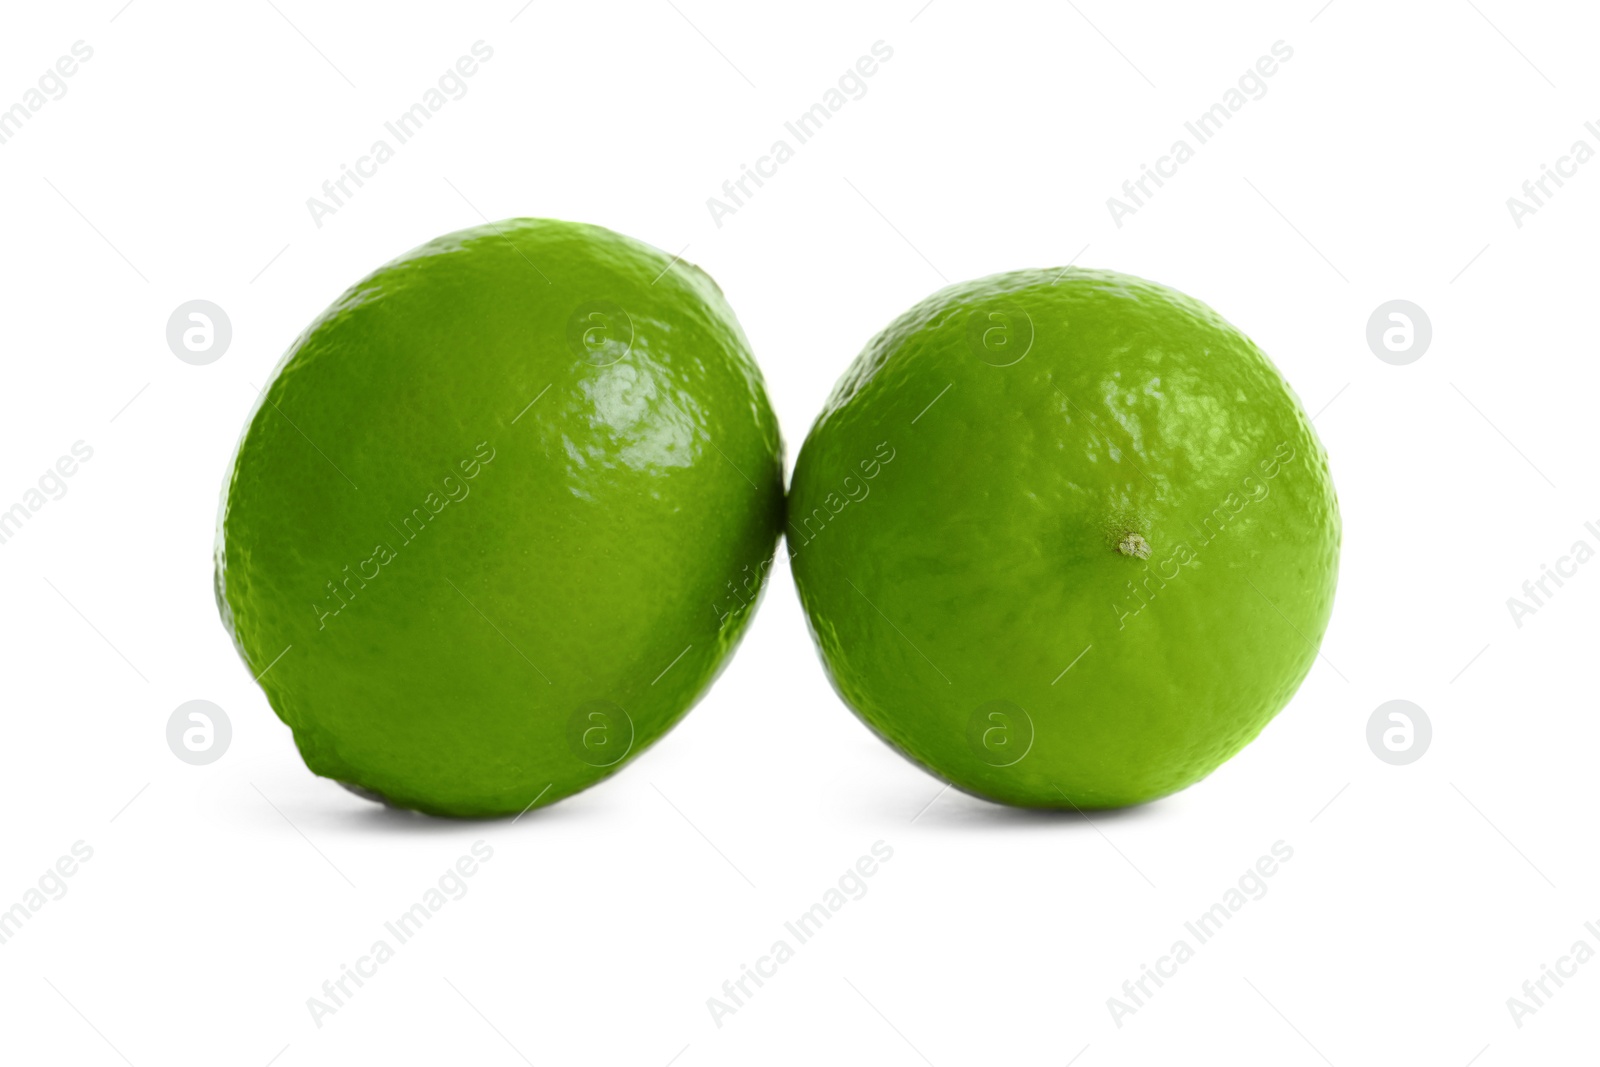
[216,219,782,816]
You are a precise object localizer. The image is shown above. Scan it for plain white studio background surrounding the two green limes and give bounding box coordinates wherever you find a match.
[0,0,1600,1067]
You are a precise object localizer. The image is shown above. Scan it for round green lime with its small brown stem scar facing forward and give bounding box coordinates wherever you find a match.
[787,270,1339,808]
